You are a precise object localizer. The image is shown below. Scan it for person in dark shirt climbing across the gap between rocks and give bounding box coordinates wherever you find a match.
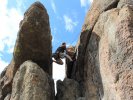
[52,42,73,65]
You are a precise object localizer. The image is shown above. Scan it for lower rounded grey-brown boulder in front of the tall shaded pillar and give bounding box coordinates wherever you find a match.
[10,61,55,100]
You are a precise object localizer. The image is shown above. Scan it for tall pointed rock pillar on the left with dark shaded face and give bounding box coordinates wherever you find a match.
[0,2,52,100]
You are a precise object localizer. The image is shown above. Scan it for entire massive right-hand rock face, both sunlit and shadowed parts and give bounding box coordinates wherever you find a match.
[69,0,133,100]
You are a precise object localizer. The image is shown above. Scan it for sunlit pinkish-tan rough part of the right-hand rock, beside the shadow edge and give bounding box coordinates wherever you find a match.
[90,6,133,100]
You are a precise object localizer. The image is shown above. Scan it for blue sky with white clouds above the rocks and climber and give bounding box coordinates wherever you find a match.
[0,0,92,72]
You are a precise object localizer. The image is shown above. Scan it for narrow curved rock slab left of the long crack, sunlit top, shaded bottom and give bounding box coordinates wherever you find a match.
[74,0,119,94]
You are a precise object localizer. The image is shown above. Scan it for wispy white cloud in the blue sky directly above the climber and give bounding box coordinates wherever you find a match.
[63,15,78,32]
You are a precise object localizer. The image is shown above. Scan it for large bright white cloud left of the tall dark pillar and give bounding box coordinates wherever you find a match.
[0,0,23,53]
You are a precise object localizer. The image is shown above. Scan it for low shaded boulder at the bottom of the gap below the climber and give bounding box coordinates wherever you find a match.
[56,78,81,100]
